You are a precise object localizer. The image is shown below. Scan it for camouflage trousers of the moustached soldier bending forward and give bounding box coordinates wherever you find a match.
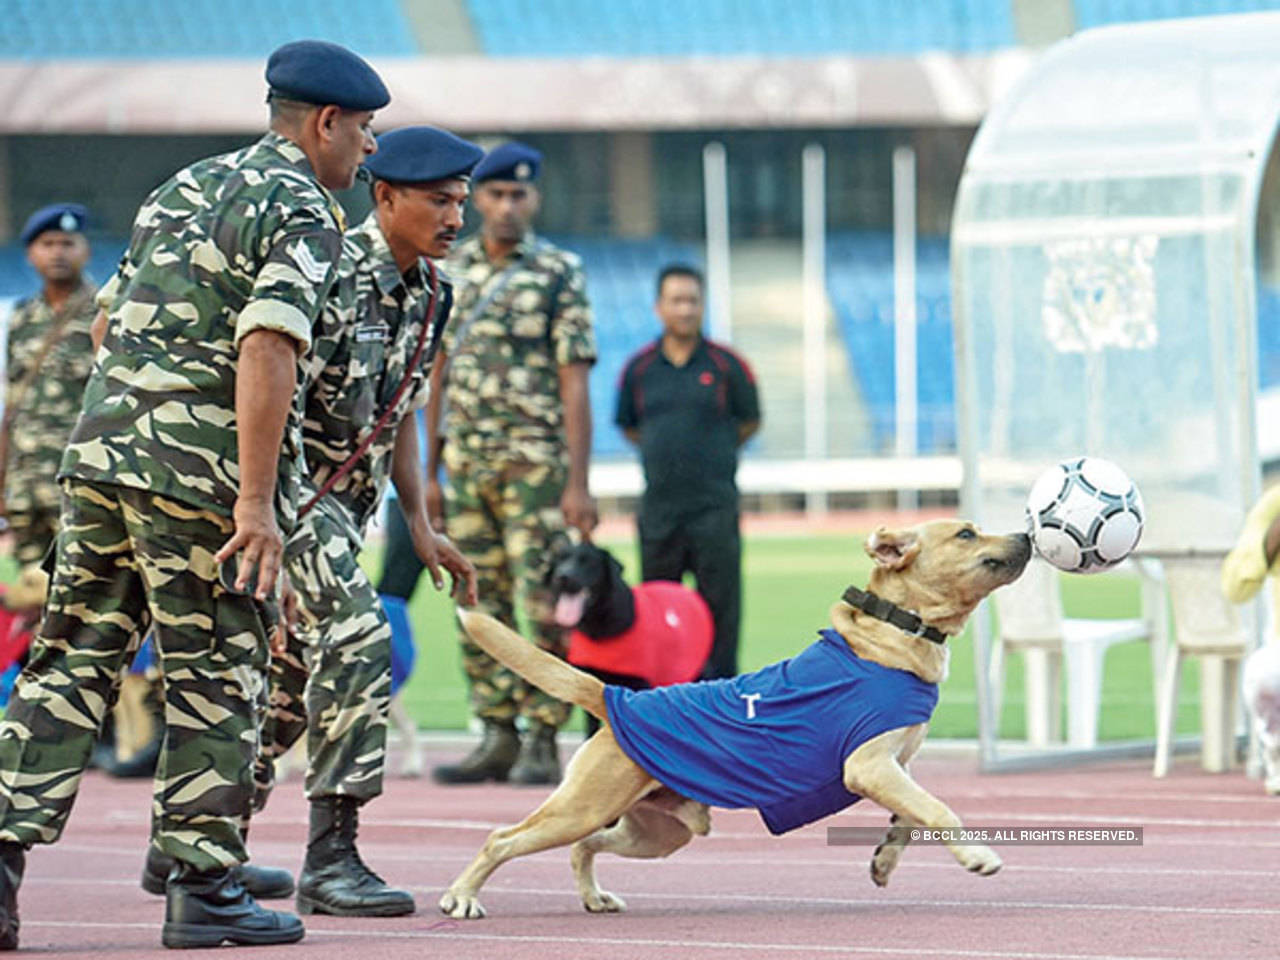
[255,497,392,809]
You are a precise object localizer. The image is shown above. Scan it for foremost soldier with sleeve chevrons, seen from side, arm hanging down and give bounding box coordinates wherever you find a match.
[0,41,389,948]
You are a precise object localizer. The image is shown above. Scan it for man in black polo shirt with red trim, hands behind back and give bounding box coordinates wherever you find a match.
[616,264,760,678]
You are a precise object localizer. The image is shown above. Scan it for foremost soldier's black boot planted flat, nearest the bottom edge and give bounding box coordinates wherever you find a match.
[160,863,306,948]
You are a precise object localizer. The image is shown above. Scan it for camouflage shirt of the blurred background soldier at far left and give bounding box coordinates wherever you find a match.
[5,282,97,513]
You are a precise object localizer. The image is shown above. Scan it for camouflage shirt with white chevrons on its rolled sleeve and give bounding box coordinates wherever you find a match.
[61,133,342,530]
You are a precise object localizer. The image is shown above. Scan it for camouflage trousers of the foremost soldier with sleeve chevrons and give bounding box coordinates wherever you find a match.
[0,481,269,870]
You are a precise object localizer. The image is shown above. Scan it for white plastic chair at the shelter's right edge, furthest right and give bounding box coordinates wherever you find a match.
[1152,557,1253,777]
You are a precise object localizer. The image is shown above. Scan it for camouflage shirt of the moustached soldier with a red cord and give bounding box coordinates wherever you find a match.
[303,212,453,545]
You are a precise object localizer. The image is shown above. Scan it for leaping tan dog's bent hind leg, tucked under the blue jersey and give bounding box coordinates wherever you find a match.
[570,797,710,914]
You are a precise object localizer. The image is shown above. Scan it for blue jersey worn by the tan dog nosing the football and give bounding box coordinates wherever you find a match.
[604,630,938,833]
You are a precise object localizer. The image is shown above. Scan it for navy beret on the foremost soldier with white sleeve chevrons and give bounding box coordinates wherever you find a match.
[266,40,392,110]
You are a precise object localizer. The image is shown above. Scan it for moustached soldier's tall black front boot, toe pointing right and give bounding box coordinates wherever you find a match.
[296,796,417,916]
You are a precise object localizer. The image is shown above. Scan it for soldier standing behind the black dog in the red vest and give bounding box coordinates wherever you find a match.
[428,143,596,783]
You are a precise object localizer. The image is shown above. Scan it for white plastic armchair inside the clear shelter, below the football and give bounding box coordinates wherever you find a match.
[989,557,1169,749]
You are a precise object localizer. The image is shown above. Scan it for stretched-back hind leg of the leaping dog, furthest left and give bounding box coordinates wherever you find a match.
[440,728,655,920]
